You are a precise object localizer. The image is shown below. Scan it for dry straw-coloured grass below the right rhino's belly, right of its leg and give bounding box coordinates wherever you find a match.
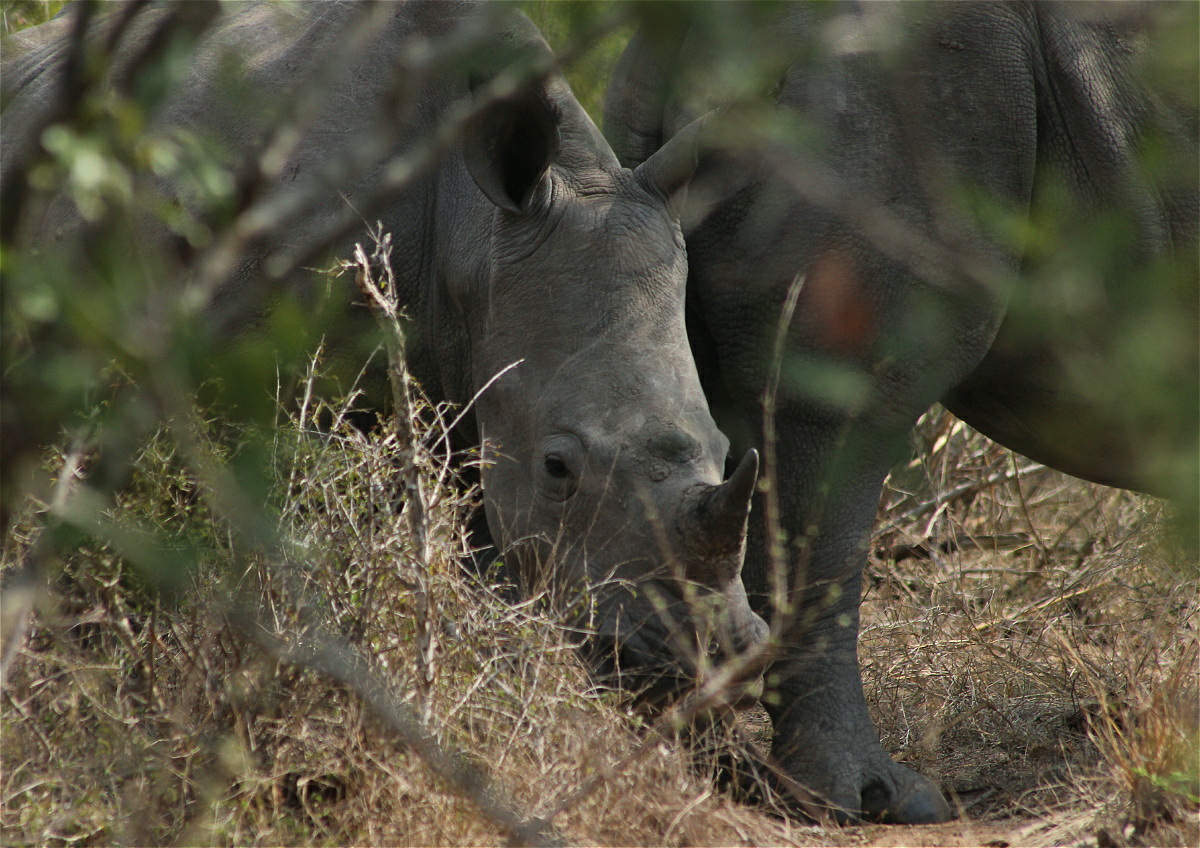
[862,413,1200,846]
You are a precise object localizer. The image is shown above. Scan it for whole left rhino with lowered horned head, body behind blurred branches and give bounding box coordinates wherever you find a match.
[4,2,766,693]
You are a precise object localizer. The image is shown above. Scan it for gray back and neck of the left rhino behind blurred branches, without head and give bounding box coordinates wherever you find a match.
[0,0,520,415]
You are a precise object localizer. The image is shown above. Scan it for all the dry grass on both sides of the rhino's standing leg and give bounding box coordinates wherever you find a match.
[0,388,1200,846]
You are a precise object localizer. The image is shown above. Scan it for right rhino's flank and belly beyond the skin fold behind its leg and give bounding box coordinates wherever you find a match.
[946,4,1200,503]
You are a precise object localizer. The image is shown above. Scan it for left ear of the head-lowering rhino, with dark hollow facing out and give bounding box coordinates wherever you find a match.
[462,86,559,212]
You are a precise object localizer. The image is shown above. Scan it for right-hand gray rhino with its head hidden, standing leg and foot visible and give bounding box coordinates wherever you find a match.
[605,4,1200,823]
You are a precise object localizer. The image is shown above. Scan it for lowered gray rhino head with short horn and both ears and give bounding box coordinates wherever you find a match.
[463,77,767,697]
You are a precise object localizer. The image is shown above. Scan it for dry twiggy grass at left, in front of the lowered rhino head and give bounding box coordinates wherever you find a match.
[0,374,788,844]
